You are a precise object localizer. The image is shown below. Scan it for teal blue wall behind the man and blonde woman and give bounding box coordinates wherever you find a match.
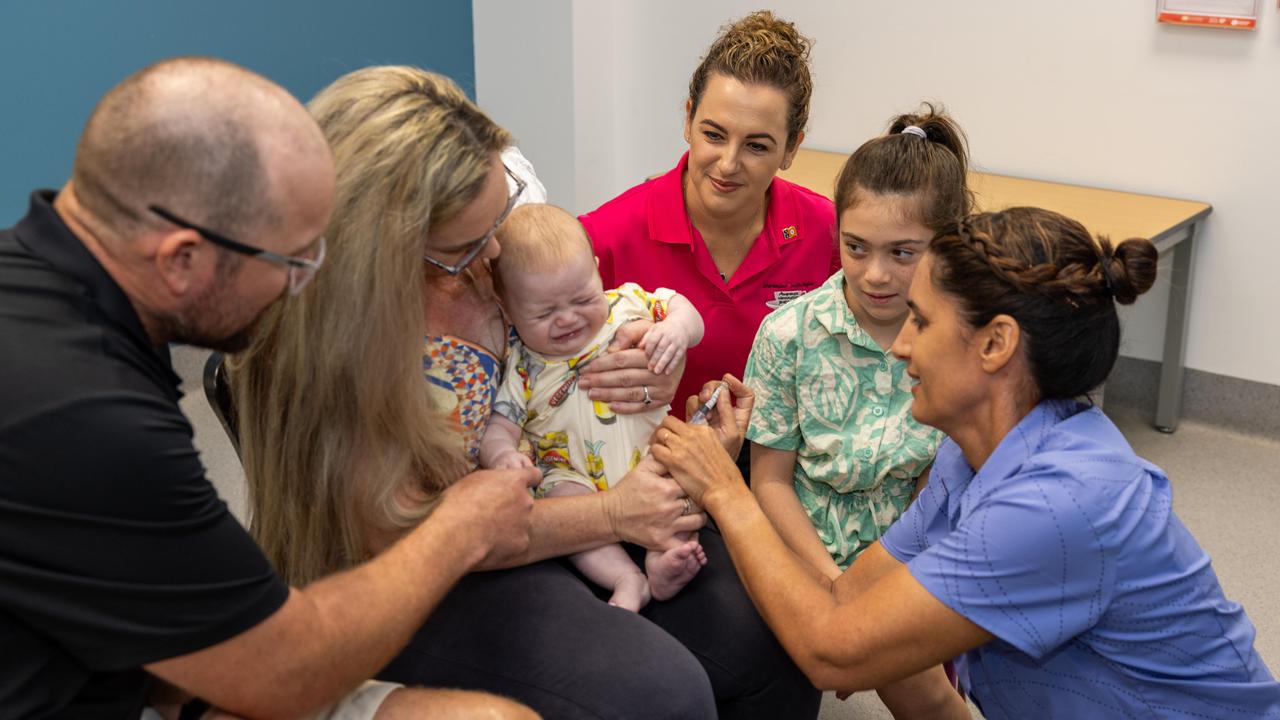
[0,0,475,227]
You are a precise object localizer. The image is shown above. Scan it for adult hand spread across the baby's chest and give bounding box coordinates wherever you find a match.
[577,320,685,415]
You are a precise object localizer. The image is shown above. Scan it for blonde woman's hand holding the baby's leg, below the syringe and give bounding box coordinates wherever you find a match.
[599,456,707,550]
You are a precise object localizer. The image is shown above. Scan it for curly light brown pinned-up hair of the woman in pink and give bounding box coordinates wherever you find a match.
[689,10,813,150]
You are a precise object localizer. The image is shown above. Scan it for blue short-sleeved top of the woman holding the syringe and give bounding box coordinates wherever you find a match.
[881,400,1280,720]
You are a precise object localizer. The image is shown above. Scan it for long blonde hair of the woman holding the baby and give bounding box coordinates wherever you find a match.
[229,67,511,584]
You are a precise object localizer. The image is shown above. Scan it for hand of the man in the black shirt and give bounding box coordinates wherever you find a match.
[426,468,541,570]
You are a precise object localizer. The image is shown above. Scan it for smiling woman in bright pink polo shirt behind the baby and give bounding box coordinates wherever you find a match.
[580,10,840,430]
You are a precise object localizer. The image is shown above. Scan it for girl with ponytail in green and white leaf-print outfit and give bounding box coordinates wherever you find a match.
[745,105,972,717]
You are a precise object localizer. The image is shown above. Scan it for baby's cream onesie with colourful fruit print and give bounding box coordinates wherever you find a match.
[493,283,676,496]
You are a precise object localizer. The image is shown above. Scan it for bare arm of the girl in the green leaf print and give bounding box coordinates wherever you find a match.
[751,443,840,579]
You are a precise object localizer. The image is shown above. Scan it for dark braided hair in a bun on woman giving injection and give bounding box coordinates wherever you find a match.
[929,208,1157,398]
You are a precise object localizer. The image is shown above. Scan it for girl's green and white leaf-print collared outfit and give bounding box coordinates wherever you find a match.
[745,273,943,569]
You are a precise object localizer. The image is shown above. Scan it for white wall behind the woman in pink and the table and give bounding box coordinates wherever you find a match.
[474,0,1280,384]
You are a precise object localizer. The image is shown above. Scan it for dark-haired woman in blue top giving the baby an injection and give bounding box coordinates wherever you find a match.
[652,208,1280,720]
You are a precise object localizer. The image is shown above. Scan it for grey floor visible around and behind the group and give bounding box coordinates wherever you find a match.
[174,347,1280,720]
